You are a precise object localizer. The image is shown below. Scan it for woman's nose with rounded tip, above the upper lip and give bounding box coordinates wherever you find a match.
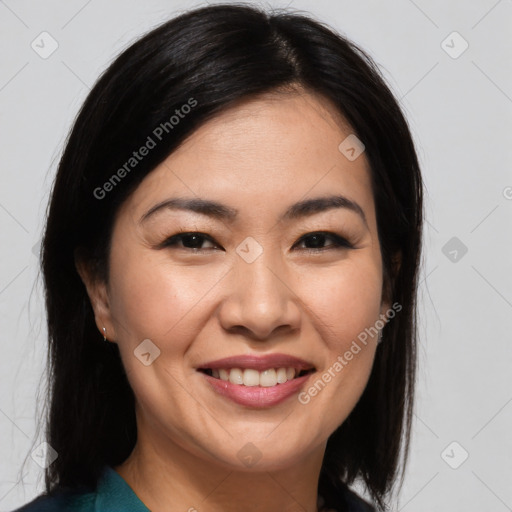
[219,251,301,341]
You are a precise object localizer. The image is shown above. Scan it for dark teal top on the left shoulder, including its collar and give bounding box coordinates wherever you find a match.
[14,466,150,512]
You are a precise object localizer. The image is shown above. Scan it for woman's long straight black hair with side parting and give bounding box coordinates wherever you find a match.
[38,4,423,506]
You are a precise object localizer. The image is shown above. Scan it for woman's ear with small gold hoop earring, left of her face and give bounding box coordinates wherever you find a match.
[75,252,117,341]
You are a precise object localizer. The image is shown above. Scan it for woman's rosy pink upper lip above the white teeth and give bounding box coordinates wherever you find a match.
[197,354,315,371]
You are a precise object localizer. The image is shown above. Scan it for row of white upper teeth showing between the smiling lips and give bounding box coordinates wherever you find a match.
[199,367,315,387]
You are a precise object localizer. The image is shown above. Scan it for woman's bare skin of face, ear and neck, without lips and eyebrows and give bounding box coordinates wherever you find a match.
[78,91,389,512]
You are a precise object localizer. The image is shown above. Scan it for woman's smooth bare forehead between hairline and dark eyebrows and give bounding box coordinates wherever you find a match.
[120,93,373,228]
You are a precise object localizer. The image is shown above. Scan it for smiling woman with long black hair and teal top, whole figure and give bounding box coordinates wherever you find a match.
[19,5,422,512]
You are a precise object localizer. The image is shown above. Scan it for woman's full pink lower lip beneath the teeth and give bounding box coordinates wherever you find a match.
[200,372,313,408]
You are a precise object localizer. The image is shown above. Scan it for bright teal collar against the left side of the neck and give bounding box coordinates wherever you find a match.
[94,466,150,512]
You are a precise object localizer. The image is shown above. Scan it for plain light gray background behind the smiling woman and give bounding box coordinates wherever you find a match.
[0,0,512,512]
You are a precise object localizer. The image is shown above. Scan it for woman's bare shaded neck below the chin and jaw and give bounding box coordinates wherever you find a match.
[115,420,325,512]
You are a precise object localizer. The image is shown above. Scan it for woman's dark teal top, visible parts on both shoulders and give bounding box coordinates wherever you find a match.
[13,466,375,512]
